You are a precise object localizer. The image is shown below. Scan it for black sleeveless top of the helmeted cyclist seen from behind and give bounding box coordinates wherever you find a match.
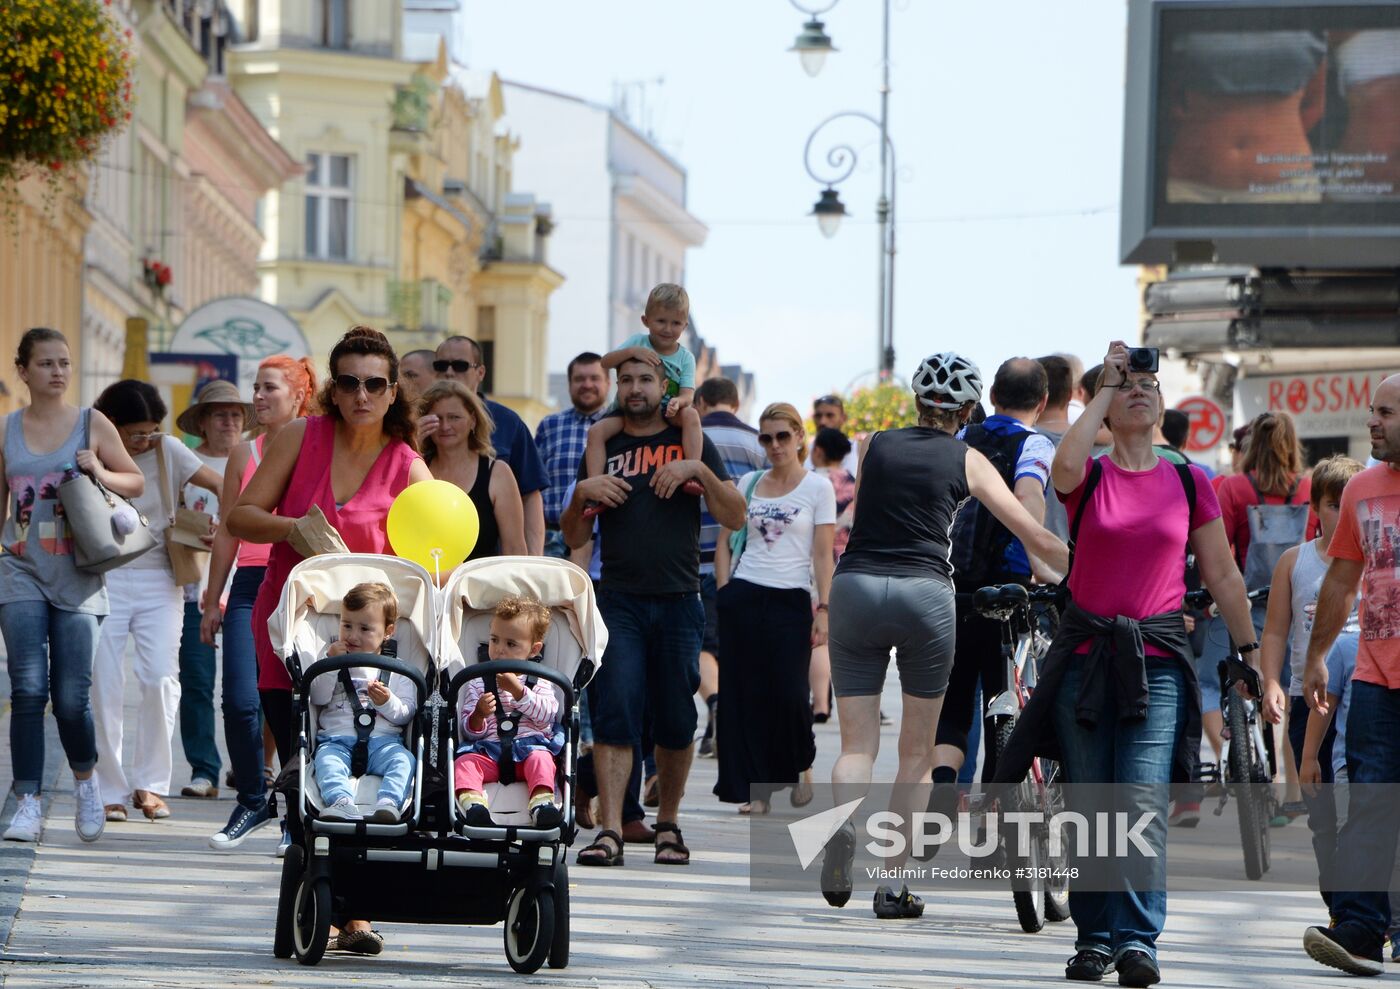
[836,426,967,583]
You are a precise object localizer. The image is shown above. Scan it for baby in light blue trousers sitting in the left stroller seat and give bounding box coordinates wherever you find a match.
[308,583,417,824]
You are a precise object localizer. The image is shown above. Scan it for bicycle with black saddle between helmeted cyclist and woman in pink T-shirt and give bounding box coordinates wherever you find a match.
[973,584,1070,934]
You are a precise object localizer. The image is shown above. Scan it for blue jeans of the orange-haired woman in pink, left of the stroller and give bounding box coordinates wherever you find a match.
[224,566,267,810]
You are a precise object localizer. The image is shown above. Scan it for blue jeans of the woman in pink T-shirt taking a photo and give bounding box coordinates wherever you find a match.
[1054,657,1186,960]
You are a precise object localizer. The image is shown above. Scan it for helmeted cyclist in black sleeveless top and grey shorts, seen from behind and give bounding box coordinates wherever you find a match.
[817,352,1067,919]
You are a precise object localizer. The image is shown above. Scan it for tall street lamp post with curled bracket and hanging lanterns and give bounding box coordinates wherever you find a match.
[788,0,896,380]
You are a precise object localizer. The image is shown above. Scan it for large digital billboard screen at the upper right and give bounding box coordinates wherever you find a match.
[1124,0,1400,263]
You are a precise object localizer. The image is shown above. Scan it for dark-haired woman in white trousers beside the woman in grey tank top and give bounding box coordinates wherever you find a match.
[92,380,224,821]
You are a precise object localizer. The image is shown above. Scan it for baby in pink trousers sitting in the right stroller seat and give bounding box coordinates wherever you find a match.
[455,597,564,828]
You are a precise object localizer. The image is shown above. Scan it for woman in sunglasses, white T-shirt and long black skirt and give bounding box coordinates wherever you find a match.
[714,402,836,814]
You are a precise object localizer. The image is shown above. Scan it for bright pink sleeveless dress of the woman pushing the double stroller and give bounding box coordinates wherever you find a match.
[253,416,420,691]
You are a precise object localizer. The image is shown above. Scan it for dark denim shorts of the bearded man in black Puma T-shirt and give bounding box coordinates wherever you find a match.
[588,587,704,748]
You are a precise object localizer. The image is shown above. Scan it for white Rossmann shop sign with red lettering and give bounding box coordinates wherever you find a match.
[1235,368,1393,438]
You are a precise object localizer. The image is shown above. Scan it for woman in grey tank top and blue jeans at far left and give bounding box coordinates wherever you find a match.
[0,326,146,842]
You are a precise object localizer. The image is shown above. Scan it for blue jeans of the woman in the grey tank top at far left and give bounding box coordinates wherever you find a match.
[0,601,102,796]
